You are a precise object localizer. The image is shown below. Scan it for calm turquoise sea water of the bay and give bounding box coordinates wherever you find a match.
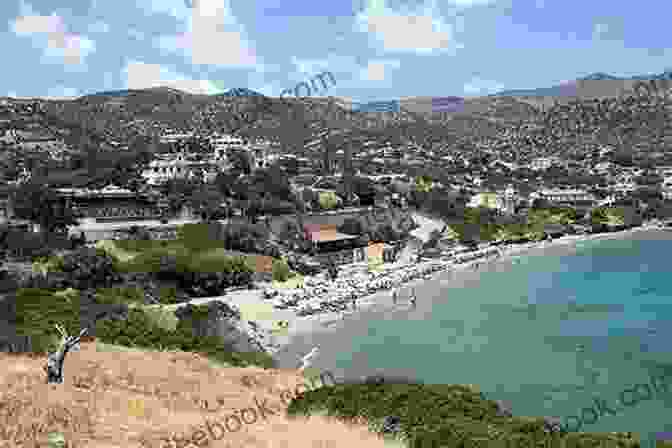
[276,239,672,446]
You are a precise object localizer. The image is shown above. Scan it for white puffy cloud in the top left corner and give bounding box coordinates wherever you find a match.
[11,3,96,65]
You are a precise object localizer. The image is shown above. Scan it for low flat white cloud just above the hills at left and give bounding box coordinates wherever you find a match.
[124,61,222,95]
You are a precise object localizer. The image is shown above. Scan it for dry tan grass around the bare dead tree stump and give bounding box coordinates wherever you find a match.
[0,341,400,448]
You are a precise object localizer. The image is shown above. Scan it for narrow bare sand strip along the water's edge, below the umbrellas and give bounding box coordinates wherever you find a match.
[266,225,672,357]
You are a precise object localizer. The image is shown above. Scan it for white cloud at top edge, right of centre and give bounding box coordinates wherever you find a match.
[355,0,462,53]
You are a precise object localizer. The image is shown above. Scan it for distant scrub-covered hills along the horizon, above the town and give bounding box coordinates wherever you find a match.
[0,69,669,169]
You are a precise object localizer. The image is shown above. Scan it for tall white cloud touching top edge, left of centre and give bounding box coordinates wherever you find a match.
[155,0,263,69]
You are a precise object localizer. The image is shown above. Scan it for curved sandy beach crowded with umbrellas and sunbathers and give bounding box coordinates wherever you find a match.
[168,222,672,367]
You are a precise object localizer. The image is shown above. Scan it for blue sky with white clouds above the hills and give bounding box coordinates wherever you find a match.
[0,0,672,101]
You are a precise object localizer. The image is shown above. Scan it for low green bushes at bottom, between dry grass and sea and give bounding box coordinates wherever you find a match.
[287,381,637,448]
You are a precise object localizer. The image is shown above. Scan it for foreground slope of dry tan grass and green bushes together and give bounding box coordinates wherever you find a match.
[0,340,640,448]
